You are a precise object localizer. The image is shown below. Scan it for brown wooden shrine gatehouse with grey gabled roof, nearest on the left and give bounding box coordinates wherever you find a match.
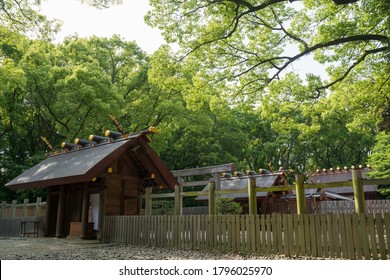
[6,128,178,239]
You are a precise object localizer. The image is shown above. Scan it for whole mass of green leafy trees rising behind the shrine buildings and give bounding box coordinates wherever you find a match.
[0,0,390,200]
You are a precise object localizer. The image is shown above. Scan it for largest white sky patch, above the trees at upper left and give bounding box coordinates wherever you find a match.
[41,0,164,54]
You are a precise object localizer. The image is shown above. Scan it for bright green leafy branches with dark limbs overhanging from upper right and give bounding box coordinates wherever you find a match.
[146,0,390,98]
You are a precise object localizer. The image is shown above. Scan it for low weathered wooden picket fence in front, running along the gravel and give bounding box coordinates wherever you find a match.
[102,213,390,259]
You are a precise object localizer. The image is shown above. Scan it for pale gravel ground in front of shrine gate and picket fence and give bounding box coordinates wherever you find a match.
[0,237,316,260]
